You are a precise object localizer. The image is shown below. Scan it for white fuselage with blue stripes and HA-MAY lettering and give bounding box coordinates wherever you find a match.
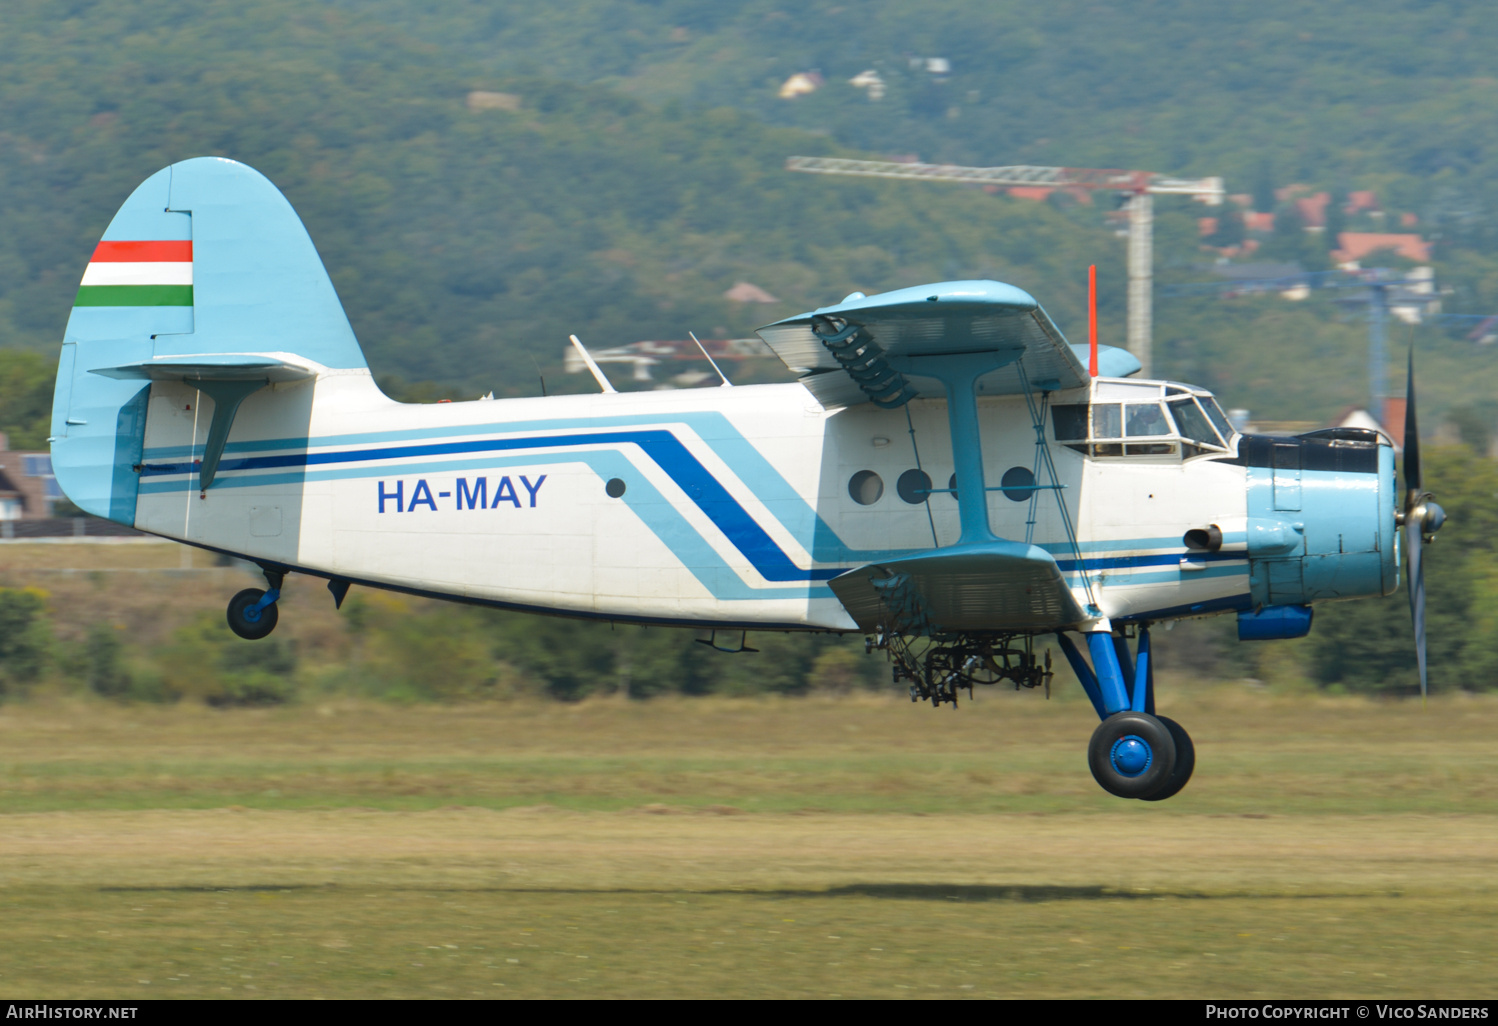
[128,370,1249,631]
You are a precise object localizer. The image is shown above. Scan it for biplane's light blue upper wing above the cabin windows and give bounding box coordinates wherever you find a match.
[759,282,1138,407]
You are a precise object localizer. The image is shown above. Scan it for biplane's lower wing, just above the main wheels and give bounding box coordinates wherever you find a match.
[828,541,1086,635]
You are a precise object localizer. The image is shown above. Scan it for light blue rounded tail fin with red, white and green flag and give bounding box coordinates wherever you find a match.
[51,157,367,524]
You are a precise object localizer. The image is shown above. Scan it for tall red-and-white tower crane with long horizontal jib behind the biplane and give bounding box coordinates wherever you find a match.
[785,157,1222,377]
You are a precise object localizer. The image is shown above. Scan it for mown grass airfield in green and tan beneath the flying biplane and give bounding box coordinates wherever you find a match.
[0,686,1498,998]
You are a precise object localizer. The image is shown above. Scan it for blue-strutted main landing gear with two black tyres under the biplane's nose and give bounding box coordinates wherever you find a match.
[1056,626,1197,801]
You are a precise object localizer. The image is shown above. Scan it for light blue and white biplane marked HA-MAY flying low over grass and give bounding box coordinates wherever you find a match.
[51,157,1444,800]
